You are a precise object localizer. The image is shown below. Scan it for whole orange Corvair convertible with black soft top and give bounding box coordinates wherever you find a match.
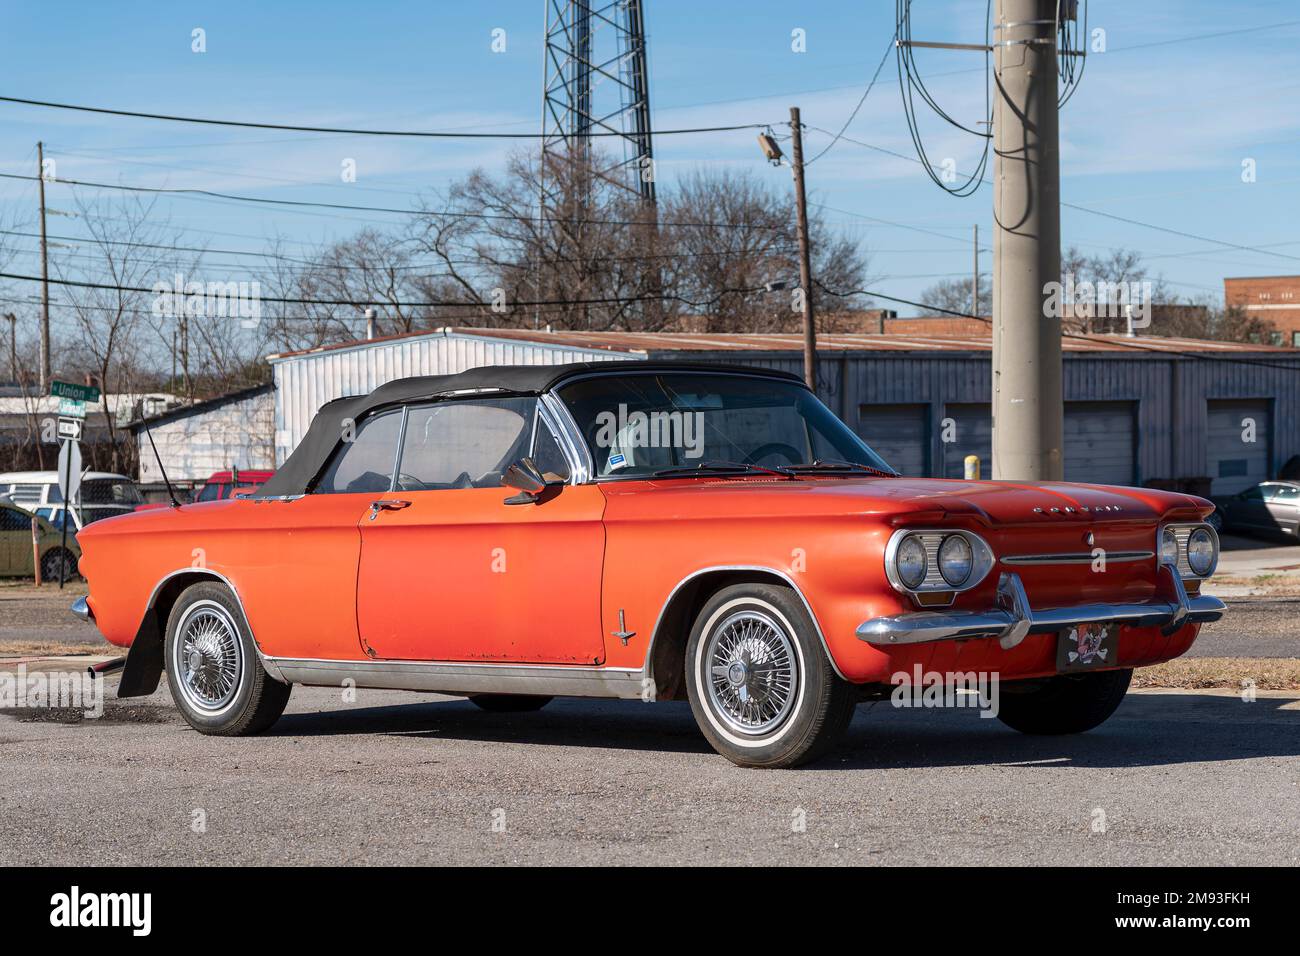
[75,362,1223,766]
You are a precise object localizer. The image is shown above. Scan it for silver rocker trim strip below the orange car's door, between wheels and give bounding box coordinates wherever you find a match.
[269,657,644,700]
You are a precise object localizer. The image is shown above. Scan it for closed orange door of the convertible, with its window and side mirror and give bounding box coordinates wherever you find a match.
[356,398,605,665]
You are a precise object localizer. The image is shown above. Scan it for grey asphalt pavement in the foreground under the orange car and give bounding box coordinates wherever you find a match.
[0,682,1300,866]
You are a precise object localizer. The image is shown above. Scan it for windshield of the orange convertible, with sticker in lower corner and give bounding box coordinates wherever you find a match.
[558,372,894,477]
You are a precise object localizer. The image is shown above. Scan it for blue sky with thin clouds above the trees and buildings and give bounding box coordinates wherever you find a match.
[0,0,1300,312]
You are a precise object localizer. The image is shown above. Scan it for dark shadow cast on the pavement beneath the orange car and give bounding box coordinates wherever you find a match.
[270,693,1300,770]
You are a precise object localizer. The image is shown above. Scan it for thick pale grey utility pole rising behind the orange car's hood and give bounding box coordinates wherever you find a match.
[993,0,1065,481]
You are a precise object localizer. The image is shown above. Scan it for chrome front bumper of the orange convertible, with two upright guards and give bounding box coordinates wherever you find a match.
[857,564,1227,650]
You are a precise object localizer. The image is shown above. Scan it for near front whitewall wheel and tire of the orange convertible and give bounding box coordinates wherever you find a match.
[685,584,858,767]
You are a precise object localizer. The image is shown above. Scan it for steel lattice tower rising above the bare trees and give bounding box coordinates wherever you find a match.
[542,0,655,203]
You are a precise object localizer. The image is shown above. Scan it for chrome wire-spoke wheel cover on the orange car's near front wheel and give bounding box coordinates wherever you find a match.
[705,610,800,736]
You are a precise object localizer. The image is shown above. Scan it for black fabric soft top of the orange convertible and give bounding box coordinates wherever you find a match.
[252,360,803,498]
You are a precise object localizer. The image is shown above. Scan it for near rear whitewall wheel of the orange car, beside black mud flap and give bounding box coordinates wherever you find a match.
[164,581,291,736]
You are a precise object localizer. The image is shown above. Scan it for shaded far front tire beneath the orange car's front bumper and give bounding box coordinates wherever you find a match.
[997,670,1134,735]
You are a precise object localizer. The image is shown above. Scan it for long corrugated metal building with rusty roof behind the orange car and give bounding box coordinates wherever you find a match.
[270,329,1300,493]
